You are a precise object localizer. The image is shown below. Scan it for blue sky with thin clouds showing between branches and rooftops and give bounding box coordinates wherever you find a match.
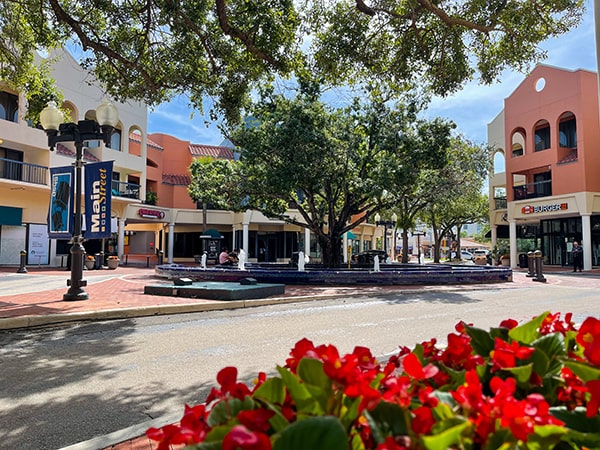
[148,0,598,145]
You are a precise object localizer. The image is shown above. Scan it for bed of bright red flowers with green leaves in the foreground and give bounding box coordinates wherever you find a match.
[147,313,600,450]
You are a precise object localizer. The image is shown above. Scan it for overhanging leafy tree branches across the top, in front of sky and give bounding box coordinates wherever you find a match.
[0,0,584,123]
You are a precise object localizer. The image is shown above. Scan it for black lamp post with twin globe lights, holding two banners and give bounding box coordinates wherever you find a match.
[40,100,119,301]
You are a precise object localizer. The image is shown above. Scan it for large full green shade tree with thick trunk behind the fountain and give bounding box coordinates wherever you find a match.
[189,82,452,267]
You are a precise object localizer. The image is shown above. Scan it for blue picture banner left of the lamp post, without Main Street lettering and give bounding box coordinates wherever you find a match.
[48,166,75,239]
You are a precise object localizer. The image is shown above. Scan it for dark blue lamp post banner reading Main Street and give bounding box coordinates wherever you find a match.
[85,161,113,239]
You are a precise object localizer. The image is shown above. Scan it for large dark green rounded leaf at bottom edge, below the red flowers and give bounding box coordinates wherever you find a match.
[273,416,348,450]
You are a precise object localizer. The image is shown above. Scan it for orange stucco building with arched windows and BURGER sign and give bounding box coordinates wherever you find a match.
[488,65,600,270]
